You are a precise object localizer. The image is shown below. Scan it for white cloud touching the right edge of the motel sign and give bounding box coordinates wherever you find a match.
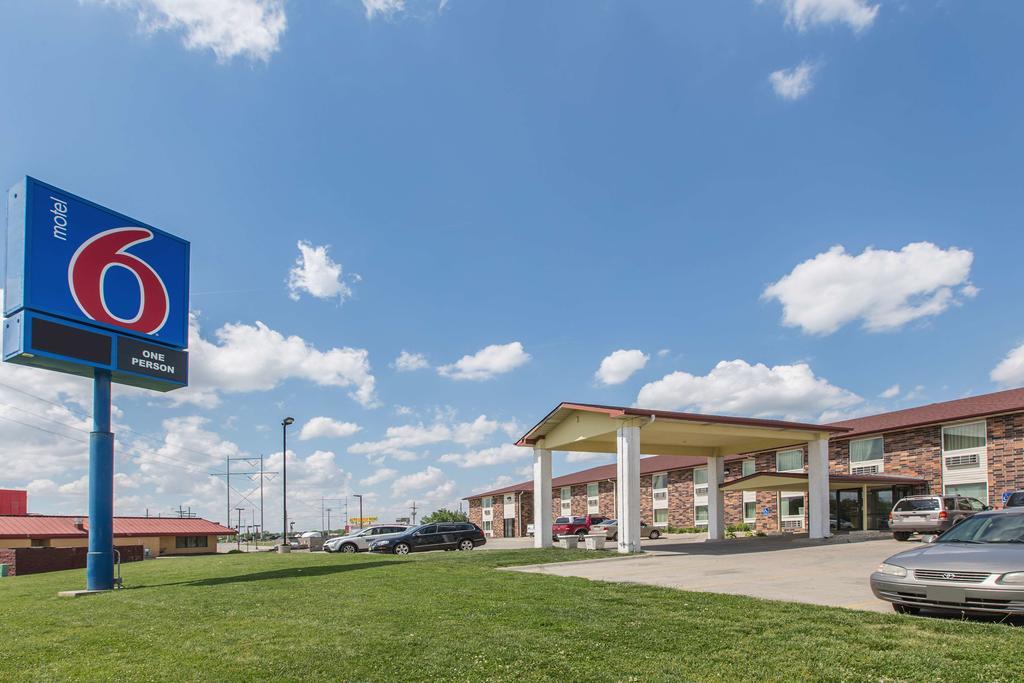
[177,314,377,408]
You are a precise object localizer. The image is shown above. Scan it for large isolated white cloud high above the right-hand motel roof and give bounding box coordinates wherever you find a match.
[762,242,977,335]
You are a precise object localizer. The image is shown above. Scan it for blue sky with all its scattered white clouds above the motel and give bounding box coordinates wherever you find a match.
[0,0,1024,527]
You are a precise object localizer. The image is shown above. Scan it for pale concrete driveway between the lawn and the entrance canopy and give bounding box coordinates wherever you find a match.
[510,537,911,611]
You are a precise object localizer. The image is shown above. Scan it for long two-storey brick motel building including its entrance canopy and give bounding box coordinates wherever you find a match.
[465,388,1024,552]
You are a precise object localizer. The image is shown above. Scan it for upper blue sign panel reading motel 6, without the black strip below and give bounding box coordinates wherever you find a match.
[4,177,188,355]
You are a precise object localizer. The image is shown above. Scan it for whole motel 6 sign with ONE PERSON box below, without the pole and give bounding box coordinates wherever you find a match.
[3,177,188,391]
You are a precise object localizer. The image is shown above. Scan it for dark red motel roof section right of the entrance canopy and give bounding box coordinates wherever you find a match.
[833,388,1024,438]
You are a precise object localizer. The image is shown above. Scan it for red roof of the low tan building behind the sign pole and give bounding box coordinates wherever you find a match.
[0,515,236,539]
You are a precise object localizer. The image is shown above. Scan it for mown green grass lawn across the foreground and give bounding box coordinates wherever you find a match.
[0,550,1024,682]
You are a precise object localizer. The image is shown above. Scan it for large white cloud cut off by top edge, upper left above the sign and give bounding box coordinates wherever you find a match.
[101,0,287,61]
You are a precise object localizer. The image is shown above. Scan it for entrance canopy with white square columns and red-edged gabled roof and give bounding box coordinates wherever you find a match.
[516,403,849,553]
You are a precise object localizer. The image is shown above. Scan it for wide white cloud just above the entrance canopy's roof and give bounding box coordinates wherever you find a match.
[637,359,862,420]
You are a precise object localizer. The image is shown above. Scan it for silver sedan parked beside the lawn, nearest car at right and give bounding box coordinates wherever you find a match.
[871,508,1024,614]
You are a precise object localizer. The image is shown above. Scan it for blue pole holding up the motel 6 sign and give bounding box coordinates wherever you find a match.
[85,369,114,591]
